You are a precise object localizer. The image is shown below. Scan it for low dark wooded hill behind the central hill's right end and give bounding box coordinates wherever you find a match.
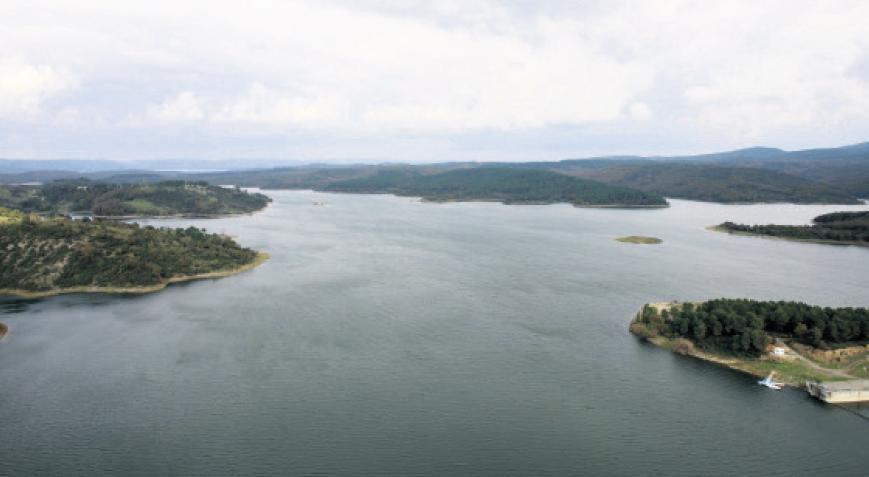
[565,161,860,204]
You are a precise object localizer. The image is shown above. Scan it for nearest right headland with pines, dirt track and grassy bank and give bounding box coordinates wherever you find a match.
[630,299,869,402]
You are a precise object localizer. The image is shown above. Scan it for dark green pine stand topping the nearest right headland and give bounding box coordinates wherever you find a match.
[637,298,869,356]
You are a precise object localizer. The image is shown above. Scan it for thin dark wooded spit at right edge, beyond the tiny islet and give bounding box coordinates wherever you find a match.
[717,211,869,246]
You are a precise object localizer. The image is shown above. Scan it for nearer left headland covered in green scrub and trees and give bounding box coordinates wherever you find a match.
[0,209,257,291]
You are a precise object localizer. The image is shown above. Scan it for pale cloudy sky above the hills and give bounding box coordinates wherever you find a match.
[0,0,869,162]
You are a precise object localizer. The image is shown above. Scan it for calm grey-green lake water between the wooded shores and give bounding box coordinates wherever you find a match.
[0,192,869,476]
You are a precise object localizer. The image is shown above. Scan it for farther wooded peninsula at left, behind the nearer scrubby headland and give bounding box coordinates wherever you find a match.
[0,180,270,216]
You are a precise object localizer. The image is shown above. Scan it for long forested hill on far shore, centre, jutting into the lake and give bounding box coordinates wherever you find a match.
[324,167,667,207]
